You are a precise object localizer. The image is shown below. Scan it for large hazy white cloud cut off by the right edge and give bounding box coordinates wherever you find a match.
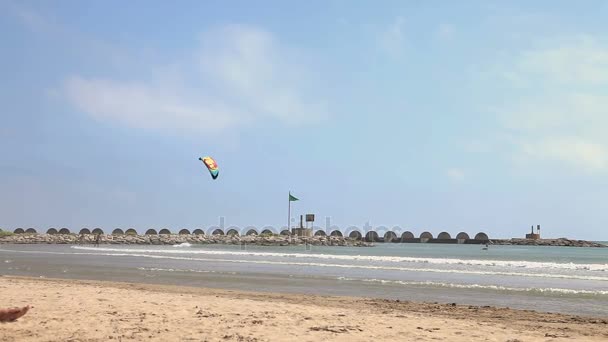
[486,36,608,172]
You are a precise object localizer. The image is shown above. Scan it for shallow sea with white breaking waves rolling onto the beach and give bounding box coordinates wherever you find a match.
[0,243,608,317]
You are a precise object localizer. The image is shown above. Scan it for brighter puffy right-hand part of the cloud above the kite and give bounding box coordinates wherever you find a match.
[199,26,325,123]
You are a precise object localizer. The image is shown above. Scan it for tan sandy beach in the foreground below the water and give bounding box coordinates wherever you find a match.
[0,276,608,342]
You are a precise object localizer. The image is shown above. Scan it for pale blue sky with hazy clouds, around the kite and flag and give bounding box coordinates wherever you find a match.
[0,0,608,240]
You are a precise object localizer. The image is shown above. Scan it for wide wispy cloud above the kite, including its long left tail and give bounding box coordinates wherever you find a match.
[63,26,326,133]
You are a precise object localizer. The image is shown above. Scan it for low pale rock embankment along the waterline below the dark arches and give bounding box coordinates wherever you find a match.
[0,234,373,247]
